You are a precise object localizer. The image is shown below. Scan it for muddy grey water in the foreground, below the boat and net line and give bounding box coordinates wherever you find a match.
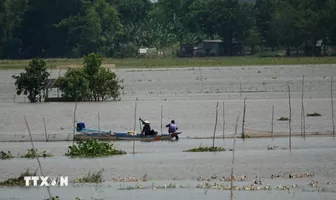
[0,137,336,199]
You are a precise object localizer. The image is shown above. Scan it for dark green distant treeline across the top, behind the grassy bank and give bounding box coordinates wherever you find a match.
[0,0,336,59]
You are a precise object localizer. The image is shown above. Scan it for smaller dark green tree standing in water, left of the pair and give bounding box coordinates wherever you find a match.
[13,58,50,102]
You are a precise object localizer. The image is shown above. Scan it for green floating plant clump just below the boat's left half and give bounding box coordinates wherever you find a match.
[65,139,126,157]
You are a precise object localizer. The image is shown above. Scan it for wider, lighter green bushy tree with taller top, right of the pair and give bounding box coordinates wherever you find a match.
[58,53,123,101]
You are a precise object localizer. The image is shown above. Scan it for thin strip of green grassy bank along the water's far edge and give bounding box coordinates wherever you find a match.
[0,56,336,69]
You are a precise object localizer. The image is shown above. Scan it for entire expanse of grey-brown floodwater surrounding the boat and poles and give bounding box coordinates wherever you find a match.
[0,65,336,200]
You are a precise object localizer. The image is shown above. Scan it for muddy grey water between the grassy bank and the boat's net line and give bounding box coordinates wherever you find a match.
[0,65,336,141]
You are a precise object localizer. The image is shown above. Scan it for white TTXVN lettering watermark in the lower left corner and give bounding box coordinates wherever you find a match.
[24,176,69,187]
